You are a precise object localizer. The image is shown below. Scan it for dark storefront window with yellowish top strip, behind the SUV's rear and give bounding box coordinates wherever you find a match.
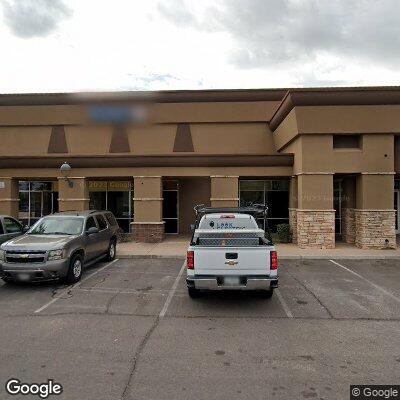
[89,181,133,232]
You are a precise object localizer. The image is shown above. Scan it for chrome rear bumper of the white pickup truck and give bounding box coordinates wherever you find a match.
[186,275,278,290]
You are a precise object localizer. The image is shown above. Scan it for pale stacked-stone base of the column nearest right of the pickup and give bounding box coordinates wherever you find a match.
[296,209,335,249]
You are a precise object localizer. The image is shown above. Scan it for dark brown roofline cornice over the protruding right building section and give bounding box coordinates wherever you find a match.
[269,86,400,131]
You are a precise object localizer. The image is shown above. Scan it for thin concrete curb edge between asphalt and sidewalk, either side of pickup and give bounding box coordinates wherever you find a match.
[117,252,400,261]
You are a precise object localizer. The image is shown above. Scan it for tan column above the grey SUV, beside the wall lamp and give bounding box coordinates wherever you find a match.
[58,177,89,211]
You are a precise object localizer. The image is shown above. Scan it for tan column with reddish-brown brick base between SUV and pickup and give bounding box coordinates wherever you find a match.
[132,176,164,243]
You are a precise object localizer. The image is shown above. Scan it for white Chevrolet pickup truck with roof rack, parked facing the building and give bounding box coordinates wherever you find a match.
[186,206,278,298]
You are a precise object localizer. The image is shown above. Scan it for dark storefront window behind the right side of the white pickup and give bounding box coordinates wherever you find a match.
[239,179,289,232]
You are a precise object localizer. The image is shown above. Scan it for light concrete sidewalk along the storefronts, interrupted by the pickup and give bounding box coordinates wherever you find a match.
[117,236,400,260]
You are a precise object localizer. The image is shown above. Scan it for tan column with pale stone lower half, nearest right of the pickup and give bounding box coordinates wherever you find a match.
[296,172,335,249]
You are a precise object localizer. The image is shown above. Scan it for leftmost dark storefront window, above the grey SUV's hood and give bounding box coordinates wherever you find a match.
[18,181,58,226]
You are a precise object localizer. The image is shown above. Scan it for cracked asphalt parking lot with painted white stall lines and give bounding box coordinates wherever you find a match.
[0,259,400,400]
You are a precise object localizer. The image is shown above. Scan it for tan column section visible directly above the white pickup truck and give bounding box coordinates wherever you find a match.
[210,175,239,207]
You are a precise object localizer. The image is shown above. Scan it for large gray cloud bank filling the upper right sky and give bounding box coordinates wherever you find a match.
[158,0,400,68]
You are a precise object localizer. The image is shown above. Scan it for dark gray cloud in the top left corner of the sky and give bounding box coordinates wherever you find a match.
[1,0,72,38]
